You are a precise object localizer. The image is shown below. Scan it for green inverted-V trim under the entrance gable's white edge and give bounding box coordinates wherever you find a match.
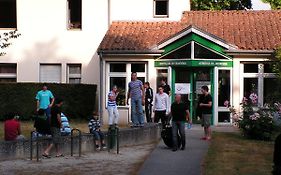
[161,33,231,58]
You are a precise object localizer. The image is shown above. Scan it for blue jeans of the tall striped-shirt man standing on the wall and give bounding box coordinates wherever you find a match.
[131,98,144,126]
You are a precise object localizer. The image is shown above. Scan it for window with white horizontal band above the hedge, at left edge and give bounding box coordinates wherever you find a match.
[0,64,17,83]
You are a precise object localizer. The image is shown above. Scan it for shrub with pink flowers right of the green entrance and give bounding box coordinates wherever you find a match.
[230,93,281,140]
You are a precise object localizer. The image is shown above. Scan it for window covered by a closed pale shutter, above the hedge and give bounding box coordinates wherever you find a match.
[40,64,61,83]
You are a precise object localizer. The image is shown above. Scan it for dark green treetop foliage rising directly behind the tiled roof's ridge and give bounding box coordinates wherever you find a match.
[191,0,252,10]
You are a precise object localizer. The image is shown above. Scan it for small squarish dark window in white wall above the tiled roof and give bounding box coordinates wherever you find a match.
[154,0,169,17]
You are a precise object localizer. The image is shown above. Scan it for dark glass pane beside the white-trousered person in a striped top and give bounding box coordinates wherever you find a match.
[110,77,126,106]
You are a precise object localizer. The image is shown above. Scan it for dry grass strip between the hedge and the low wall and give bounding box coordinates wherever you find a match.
[0,120,128,140]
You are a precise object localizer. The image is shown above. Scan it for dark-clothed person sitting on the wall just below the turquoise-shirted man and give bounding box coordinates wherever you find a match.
[33,109,51,137]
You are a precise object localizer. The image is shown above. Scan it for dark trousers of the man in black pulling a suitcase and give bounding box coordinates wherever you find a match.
[172,121,185,149]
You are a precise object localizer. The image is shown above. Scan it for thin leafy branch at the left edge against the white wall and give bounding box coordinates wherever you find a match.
[0,30,21,56]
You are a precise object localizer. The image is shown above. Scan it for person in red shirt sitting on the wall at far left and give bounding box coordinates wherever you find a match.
[4,114,25,141]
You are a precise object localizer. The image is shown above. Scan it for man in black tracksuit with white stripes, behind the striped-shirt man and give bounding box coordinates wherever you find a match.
[144,82,153,123]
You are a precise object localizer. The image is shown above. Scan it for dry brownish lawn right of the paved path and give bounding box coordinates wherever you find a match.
[203,132,274,175]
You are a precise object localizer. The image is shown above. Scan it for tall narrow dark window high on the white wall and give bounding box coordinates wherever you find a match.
[68,0,82,29]
